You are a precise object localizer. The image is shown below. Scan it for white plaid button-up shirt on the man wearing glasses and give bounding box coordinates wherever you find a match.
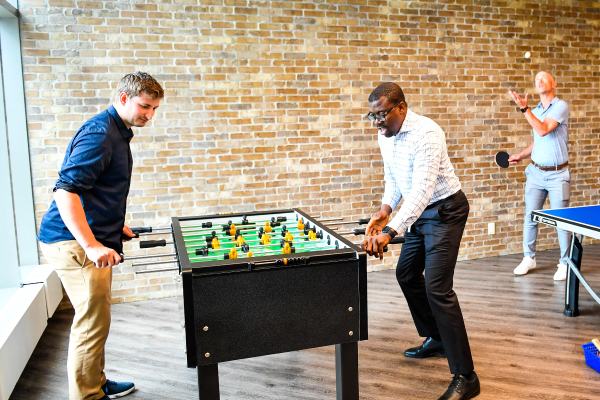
[378,110,461,234]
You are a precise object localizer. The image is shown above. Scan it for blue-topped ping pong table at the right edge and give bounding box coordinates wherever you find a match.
[531,205,600,317]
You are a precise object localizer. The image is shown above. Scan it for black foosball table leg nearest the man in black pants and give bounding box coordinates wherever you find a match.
[335,342,358,400]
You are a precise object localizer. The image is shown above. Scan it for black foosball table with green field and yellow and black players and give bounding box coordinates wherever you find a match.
[130,209,402,400]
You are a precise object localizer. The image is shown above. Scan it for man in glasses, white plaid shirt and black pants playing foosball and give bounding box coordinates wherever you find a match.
[363,82,480,400]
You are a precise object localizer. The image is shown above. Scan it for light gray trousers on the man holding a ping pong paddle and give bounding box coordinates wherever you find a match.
[523,164,571,265]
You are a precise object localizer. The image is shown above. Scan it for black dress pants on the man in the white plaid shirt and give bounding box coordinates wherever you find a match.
[396,191,474,375]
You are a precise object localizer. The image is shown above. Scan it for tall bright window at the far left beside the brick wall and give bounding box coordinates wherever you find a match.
[0,0,39,289]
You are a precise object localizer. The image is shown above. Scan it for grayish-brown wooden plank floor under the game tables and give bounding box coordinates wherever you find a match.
[11,245,600,400]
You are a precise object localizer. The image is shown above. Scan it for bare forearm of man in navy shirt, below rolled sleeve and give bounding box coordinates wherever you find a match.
[54,189,98,249]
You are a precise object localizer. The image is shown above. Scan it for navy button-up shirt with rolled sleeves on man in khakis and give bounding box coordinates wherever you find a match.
[38,106,133,253]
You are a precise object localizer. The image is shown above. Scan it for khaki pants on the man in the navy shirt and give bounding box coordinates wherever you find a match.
[40,240,112,400]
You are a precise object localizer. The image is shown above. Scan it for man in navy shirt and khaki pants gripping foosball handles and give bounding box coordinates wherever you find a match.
[38,72,164,400]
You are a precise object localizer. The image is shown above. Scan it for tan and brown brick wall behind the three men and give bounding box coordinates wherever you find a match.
[19,0,600,302]
